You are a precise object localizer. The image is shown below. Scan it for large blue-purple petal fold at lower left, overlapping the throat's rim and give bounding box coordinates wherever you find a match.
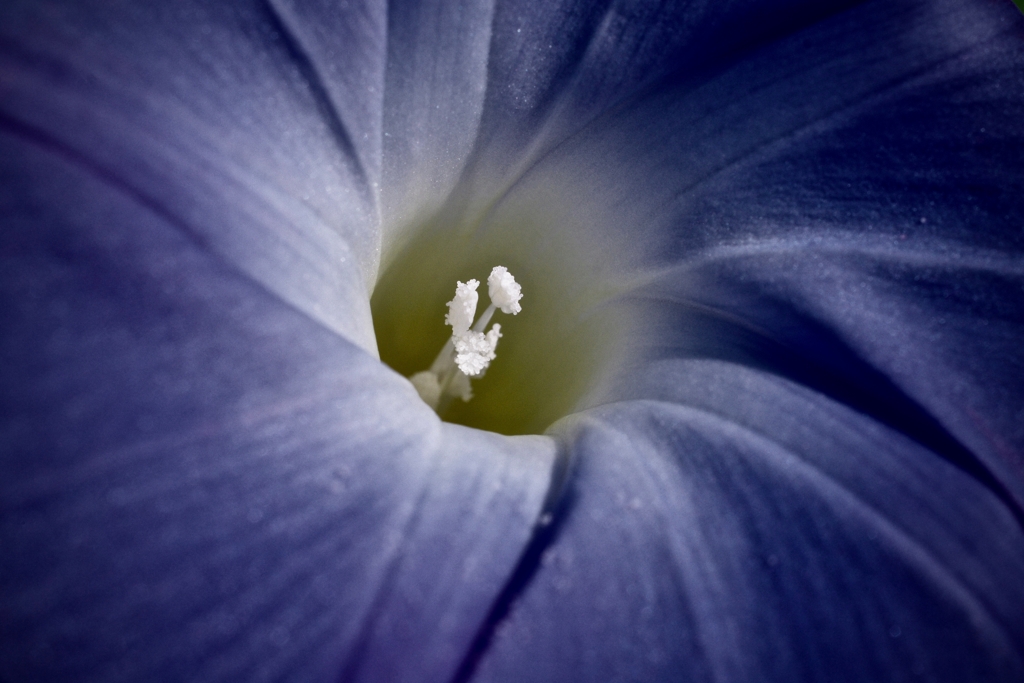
[0,134,555,681]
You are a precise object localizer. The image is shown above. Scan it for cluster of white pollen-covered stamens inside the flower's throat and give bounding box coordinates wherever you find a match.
[409,265,522,415]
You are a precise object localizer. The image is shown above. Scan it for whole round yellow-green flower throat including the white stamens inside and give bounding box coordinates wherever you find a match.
[370,192,636,435]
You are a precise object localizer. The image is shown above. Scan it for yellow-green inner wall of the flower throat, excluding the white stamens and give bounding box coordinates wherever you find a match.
[371,194,629,435]
